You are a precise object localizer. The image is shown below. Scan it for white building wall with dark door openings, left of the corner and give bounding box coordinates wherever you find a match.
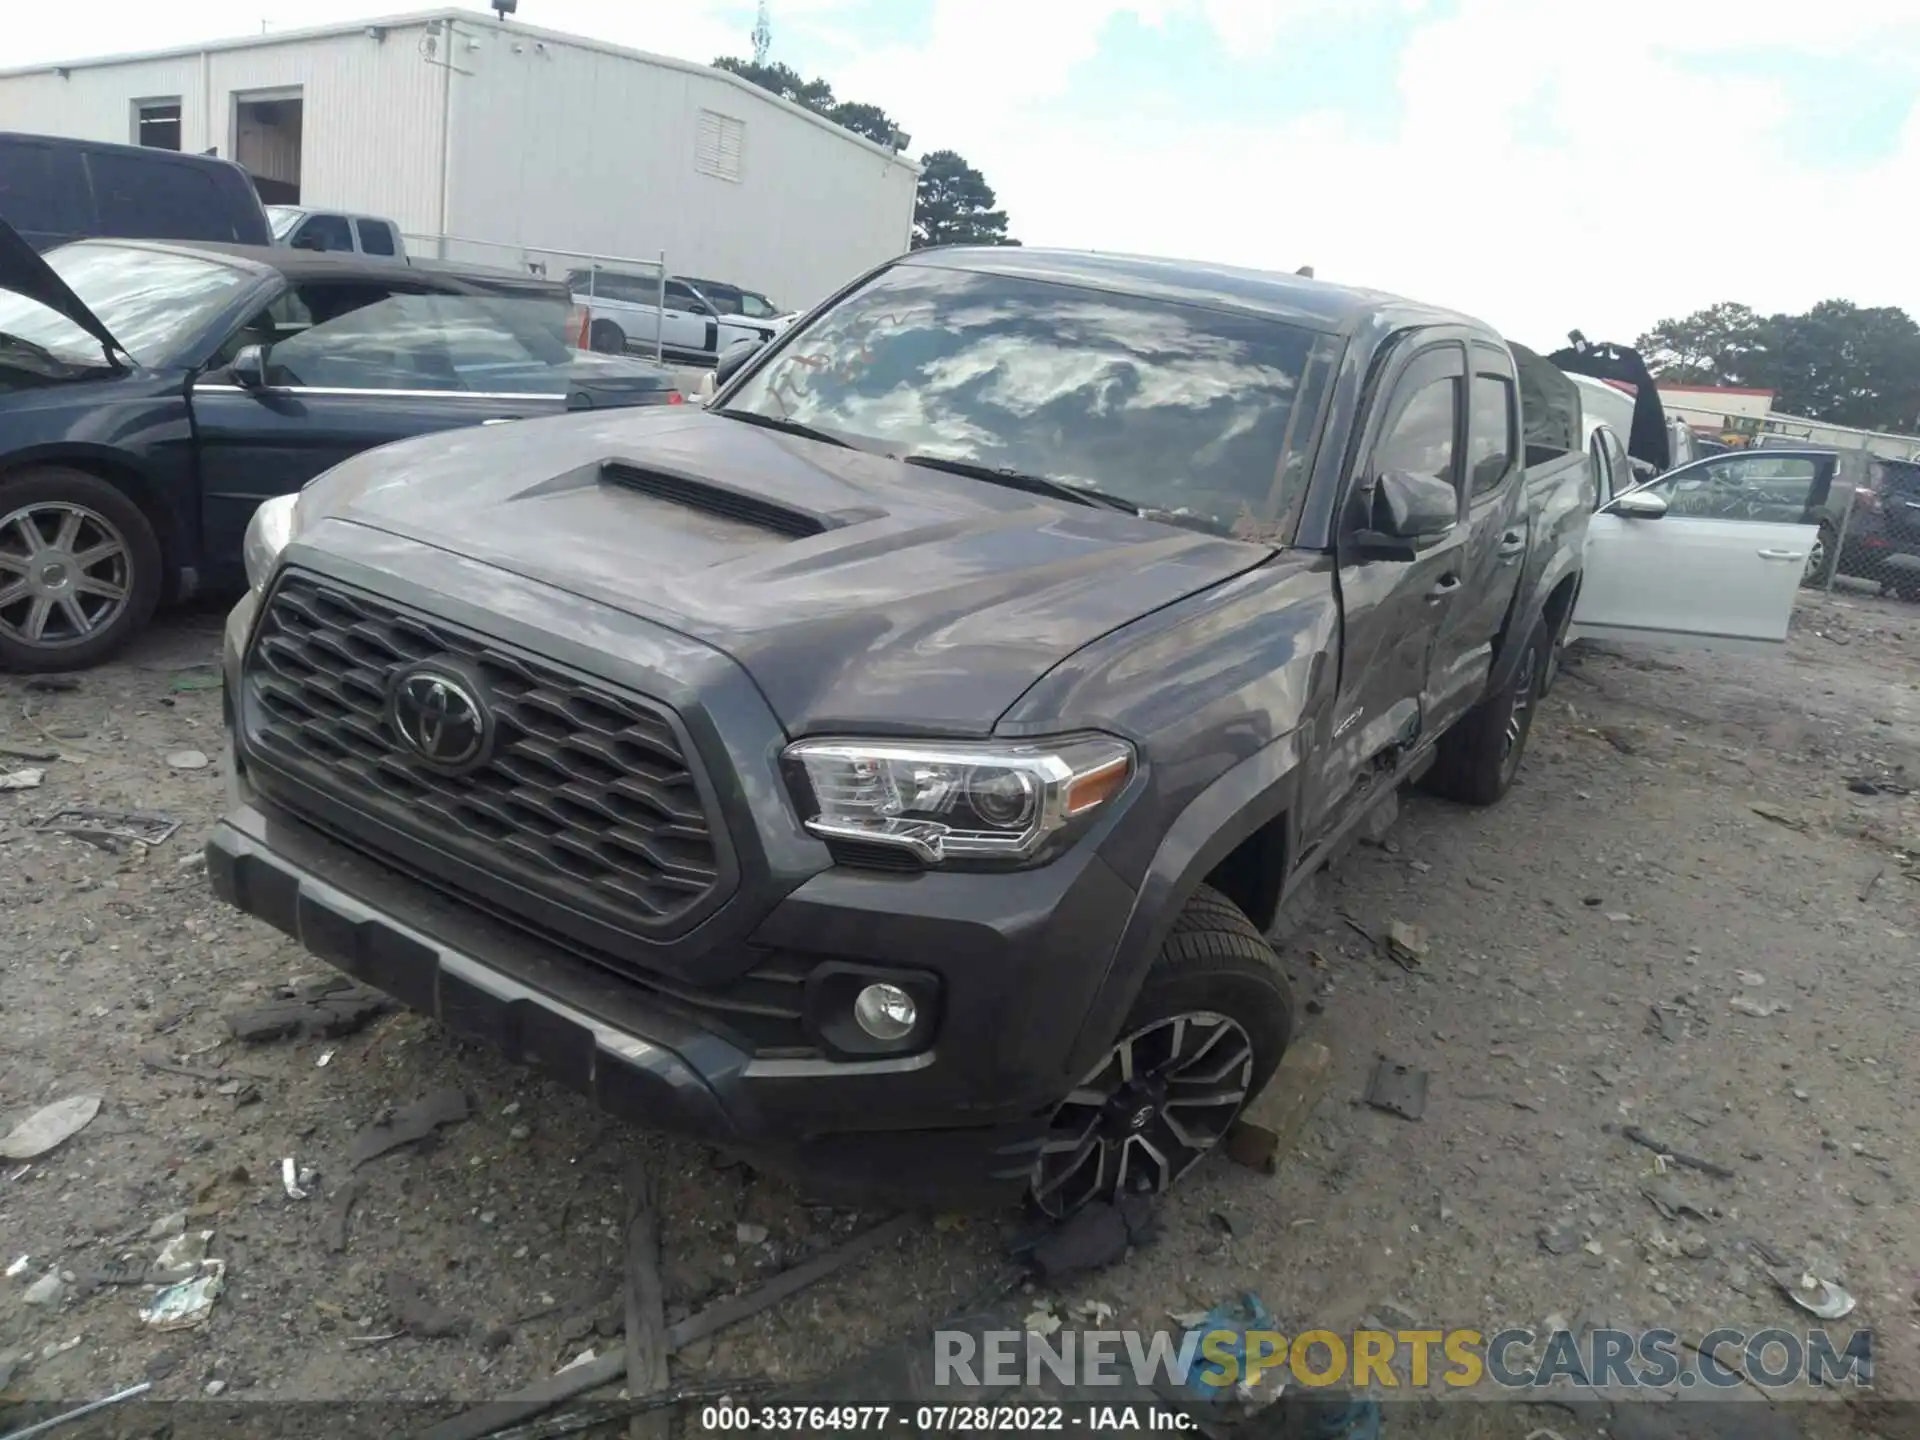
[0,25,447,230]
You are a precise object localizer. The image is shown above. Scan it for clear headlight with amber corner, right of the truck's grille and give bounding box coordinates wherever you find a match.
[785,735,1133,864]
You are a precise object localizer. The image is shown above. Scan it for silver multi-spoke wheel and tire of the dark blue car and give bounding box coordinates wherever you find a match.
[0,465,161,674]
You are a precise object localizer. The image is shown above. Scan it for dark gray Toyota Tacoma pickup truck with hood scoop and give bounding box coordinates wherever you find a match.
[207,248,1594,1213]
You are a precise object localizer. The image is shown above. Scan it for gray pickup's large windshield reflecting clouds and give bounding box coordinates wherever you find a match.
[726,263,1338,543]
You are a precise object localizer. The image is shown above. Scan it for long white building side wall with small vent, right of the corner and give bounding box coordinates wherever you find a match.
[447,23,916,307]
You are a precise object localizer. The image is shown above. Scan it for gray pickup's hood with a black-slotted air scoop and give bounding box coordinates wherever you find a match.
[296,407,1273,735]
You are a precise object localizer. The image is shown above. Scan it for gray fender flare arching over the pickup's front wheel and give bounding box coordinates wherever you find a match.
[1069,728,1306,1077]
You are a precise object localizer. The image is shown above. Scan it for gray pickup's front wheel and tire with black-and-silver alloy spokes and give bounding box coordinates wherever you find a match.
[1029,885,1294,1215]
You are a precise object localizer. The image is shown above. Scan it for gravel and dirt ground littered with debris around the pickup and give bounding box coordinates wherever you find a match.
[0,583,1920,1438]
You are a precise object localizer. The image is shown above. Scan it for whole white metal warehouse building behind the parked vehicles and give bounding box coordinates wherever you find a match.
[0,10,920,307]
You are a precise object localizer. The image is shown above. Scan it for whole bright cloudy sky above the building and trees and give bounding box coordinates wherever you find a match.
[0,0,1920,346]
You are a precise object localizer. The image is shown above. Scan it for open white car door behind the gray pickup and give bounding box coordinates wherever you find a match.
[1567,449,1837,649]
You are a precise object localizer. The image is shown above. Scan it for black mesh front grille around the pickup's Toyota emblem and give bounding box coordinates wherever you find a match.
[242,572,728,937]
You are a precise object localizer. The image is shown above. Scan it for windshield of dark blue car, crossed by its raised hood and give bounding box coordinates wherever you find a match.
[0,242,252,365]
